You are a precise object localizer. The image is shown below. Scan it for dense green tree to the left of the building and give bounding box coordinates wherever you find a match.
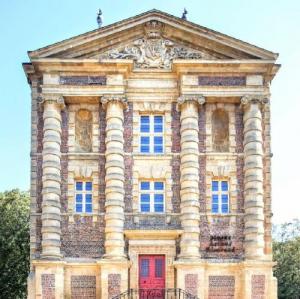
[0,189,30,299]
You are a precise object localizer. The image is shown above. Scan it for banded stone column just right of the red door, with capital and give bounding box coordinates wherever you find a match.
[177,96,205,259]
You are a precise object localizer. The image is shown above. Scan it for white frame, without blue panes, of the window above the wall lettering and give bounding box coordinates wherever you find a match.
[211,178,230,215]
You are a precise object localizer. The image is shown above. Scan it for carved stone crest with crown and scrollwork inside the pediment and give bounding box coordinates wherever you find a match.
[100,21,203,69]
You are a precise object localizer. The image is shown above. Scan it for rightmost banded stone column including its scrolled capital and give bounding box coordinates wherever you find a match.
[241,96,268,259]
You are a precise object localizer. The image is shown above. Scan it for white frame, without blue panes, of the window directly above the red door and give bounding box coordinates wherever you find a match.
[139,179,166,214]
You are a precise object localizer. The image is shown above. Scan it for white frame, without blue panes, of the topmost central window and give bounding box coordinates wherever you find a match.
[139,113,165,155]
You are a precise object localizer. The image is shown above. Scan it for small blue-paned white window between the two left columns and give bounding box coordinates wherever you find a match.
[75,181,93,213]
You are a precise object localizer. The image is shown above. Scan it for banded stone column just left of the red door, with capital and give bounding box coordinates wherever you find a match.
[101,95,126,259]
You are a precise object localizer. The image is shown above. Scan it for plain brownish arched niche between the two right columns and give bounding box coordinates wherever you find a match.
[212,109,229,152]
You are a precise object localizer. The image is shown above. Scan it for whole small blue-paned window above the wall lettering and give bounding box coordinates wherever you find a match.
[211,180,229,214]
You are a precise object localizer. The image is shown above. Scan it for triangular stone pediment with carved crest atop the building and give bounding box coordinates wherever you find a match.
[29,10,277,68]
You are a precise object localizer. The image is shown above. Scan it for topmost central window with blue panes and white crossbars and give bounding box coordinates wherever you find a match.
[140,115,164,154]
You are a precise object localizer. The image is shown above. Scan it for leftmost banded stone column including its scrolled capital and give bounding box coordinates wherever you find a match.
[39,95,64,259]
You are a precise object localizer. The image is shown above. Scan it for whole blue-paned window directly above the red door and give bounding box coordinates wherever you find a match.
[140,181,165,213]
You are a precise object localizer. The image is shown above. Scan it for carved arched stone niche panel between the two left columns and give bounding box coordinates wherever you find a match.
[75,109,93,152]
